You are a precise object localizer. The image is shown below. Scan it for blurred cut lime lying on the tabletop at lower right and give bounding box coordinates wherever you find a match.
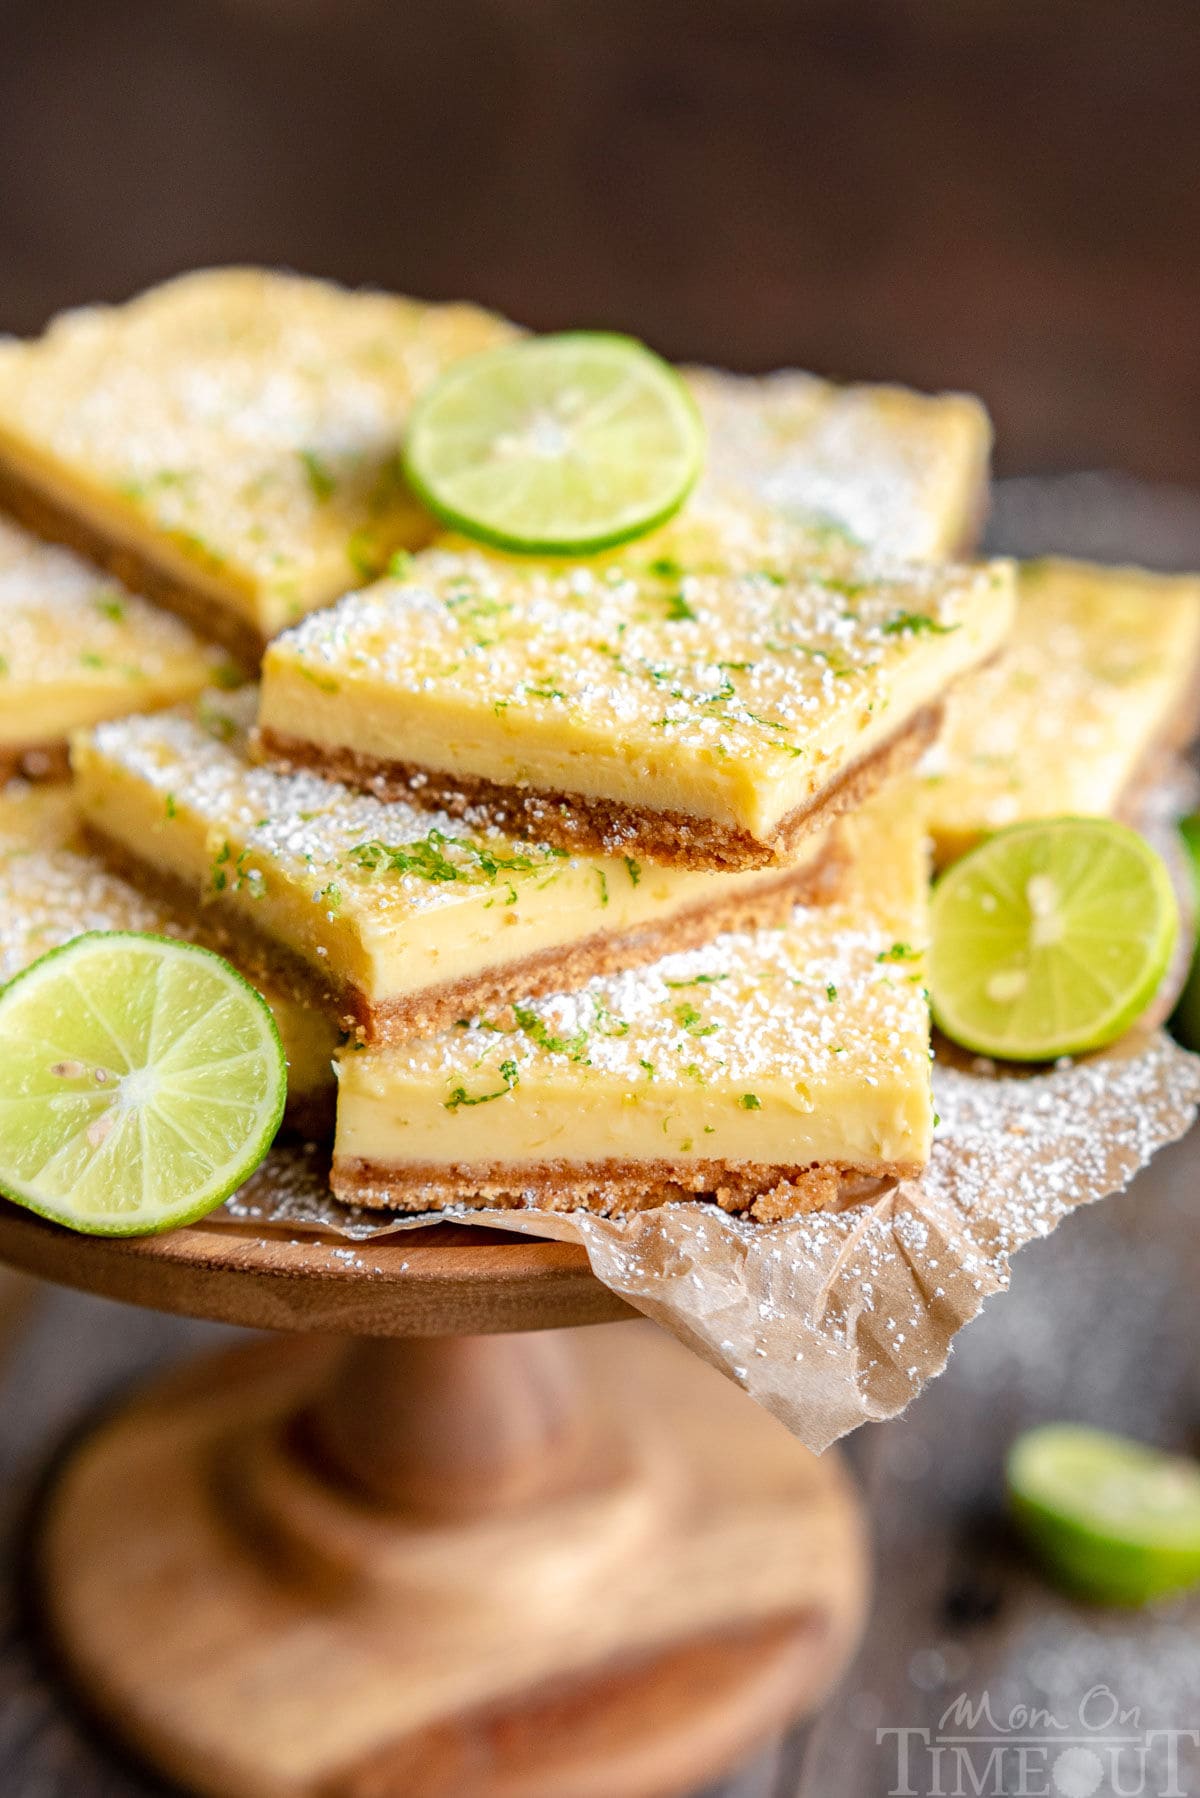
[1007,1424,1200,1604]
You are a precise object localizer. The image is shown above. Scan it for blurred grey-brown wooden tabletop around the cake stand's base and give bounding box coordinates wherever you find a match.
[0,1138,1200,1798]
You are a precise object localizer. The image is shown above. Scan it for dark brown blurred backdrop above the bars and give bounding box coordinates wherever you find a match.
[0,0,1200,485]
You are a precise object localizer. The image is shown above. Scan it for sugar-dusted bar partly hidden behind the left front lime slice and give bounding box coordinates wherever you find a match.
[0,780,338,1131]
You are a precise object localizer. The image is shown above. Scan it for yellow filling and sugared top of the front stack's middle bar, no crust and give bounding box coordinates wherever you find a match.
[74,692,822,1003]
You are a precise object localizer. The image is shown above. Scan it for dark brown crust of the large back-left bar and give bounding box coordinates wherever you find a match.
[0,457,266,674]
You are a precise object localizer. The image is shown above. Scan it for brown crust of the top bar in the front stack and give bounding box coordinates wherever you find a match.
[257,703,943,872]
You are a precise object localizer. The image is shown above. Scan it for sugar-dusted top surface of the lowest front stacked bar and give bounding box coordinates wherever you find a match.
[352,788,928,1107]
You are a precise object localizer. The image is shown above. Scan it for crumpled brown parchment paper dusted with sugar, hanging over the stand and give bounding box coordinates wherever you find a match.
[228,1032,1200,1449]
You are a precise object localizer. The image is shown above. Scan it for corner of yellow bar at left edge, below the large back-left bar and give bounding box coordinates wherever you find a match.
[0,518,236,780]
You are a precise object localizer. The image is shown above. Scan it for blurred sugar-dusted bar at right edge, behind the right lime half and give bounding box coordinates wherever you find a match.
[923,559,1200,865]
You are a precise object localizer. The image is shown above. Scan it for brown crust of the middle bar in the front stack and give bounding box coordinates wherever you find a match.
[83,822,846,1046]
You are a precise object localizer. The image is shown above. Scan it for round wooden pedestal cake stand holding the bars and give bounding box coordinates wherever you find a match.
[0,1203,867,1798]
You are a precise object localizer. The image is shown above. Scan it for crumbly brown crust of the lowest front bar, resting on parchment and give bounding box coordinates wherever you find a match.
[329,1156,919,1223]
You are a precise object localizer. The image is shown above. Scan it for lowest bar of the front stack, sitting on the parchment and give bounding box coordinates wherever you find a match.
[333,788,932,1219]
